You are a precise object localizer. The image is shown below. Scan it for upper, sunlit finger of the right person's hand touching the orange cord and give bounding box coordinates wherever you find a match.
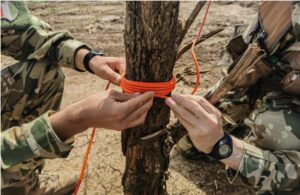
[171,95,209,120]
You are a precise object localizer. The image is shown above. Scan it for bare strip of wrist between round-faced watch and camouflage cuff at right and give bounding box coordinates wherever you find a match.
[221,136,244,170]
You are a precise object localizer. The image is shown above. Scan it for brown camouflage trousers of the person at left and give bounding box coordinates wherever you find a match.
[1,61,65,194]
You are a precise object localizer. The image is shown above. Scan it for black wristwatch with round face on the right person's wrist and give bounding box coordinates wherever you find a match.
[208,132,232,160]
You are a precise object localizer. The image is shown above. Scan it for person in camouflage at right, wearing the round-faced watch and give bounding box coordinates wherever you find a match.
[166,2,300,194]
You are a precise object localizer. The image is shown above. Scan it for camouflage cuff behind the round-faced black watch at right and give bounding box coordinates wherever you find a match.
[226,142,265,187]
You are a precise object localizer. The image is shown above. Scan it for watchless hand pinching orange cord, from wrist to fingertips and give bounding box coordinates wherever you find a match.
[81,90,154,131]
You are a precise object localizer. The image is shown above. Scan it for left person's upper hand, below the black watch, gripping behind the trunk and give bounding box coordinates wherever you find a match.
[90,56,126,85]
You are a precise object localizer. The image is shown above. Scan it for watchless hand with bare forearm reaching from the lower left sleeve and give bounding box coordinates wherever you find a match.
[49,90,154,140]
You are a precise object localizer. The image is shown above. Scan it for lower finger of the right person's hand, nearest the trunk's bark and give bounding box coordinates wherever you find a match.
[166,98,199,126]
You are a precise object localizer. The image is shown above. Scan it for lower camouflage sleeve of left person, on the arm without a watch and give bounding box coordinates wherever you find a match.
[1,111,73,170]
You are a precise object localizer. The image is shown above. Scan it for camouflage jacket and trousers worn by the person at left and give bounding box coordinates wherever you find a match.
[1,1,88,194]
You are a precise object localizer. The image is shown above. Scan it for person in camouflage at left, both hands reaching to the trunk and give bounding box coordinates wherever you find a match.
[1,1,153,195]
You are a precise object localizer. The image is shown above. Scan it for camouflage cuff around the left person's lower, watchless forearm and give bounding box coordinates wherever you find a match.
[25,111,74,159]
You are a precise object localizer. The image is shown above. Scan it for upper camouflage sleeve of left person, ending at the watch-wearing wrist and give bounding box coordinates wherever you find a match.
[1,17,90,70]
